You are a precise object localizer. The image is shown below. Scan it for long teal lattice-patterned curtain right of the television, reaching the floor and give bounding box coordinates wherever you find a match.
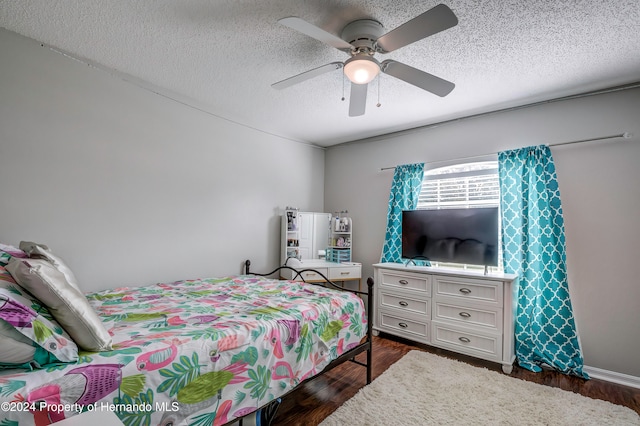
[498,145,589,378]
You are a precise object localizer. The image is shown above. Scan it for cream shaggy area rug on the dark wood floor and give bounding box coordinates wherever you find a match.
[321,351,640,426]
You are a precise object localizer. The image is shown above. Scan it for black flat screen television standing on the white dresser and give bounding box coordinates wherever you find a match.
[402,207,499,266]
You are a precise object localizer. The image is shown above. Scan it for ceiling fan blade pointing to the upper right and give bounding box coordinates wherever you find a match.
[376,4,458,53]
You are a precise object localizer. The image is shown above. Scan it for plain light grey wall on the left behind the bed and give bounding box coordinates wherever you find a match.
[0,29,324,291]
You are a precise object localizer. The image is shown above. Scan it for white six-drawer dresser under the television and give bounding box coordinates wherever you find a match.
[373,263,517,374]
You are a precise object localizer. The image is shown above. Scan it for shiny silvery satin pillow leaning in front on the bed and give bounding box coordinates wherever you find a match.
[6,258,111,352]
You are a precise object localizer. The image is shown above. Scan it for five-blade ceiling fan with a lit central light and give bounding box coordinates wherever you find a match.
[271,4,458,117]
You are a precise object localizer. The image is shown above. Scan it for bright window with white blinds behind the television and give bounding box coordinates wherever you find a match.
[417,161,502,272]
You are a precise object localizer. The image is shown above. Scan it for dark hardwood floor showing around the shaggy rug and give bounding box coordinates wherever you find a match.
[272,335,640,426]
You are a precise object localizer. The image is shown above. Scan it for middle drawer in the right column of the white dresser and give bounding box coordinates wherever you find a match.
[433,300,502,333]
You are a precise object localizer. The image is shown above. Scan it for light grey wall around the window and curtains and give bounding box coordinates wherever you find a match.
[325,85,640,376]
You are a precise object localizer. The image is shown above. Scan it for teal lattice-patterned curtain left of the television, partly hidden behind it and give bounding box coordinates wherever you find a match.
[380,163,424,263]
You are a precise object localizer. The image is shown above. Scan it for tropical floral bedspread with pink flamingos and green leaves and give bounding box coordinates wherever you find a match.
[0,276,366,426]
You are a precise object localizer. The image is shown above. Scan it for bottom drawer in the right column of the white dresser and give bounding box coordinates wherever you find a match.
[431,321,502,361]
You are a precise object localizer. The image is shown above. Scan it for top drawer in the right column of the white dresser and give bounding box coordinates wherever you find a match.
[433,276,503,306]
